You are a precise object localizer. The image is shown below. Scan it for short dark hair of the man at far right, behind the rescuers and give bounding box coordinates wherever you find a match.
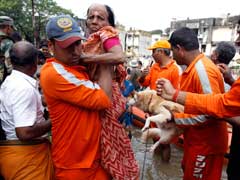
[215,41,236,64]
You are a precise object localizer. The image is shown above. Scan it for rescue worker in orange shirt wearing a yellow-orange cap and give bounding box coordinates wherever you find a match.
[139,40,182,162]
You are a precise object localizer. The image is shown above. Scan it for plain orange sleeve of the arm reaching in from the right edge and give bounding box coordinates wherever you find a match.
[184,78,240,118]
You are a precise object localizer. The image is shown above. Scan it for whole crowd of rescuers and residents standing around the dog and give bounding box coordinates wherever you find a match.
[0,4,240,180]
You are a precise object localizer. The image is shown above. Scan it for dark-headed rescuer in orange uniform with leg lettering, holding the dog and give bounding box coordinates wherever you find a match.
[157,28,228,180]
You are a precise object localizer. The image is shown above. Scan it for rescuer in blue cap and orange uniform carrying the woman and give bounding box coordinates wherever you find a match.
[40,15,112,180]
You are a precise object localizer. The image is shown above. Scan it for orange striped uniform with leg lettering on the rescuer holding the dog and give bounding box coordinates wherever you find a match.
[174,54,228,180]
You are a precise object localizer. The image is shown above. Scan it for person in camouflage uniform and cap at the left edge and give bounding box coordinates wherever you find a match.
[0,16,14,85]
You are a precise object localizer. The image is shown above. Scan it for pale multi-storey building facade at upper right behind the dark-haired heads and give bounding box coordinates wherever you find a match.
[170,15,240,55]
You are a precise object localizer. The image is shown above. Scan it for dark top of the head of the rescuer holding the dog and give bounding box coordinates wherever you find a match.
[168,27,199,51]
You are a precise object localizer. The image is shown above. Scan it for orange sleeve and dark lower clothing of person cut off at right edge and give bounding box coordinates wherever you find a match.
[185,78,240,180]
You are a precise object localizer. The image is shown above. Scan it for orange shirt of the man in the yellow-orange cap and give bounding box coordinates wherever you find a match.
[140,60,182,90]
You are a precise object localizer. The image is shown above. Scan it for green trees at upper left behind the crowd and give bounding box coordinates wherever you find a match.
[0,0,74,42]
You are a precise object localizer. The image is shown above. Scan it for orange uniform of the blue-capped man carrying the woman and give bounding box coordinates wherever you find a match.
[40,58,111,180]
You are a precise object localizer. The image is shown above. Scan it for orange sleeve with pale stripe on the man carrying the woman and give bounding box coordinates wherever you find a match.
[40,64,111,110]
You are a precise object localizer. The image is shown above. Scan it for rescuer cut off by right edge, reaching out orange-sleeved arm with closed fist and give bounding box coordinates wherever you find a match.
[157,67,240,180]
